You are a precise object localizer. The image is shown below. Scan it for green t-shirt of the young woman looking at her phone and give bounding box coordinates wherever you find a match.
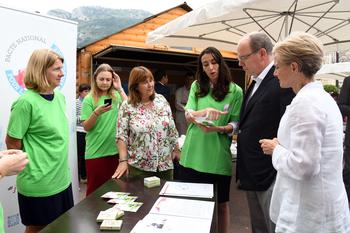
[80,92,122,159]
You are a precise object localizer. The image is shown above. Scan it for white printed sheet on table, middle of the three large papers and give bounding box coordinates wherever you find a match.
[150,197,215,220]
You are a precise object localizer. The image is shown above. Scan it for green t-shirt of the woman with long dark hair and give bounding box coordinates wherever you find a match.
[180,82,243,176]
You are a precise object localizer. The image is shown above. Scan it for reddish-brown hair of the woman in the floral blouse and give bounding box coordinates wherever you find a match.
[128,66,155,106]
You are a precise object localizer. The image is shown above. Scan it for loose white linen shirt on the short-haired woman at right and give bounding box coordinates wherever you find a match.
[270,82,350,233]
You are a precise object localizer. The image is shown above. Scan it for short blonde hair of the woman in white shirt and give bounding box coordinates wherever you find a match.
[273,32,324,78]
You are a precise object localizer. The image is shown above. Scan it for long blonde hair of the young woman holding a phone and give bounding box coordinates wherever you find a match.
[90,63,115,104]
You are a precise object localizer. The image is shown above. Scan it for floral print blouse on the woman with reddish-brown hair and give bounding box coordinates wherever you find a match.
[117,94,178,172]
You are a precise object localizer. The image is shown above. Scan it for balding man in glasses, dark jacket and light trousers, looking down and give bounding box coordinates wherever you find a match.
[236,32,294,233]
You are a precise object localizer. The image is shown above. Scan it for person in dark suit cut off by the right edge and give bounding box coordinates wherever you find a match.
[338,76,350,202]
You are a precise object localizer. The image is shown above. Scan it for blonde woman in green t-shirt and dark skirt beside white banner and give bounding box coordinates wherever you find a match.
[6,49,74,232]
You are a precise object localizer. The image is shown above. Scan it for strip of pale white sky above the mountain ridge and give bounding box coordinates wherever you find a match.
[0,0,215,14]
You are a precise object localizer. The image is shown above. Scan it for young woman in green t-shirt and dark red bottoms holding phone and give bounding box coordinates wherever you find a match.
[80,64,127,195]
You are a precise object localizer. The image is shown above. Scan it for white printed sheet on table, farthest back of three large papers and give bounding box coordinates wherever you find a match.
[159,181,214,198]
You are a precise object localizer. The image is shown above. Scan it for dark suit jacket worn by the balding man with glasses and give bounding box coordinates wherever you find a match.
[236,67,295,191]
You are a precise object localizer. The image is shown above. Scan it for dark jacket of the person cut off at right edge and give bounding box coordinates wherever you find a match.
[338,76,350,147]
